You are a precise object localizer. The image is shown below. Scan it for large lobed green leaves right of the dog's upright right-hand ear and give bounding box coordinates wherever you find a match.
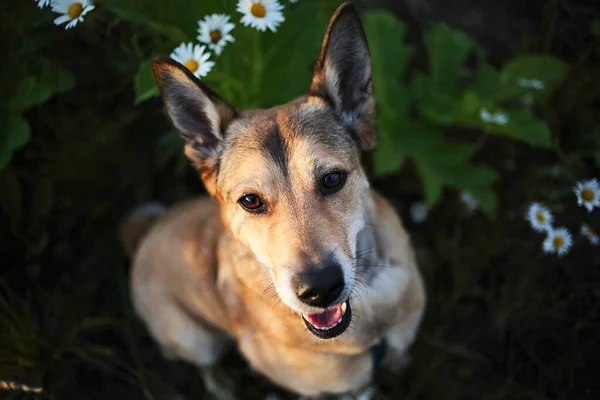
[364,11,567,214]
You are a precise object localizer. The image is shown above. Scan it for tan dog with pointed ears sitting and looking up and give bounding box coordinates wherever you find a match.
[121,3,426,396]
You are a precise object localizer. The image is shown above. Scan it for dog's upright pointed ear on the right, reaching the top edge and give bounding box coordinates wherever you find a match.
[310,2,377,150]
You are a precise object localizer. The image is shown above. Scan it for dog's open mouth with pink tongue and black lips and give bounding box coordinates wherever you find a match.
[302,299,352,339]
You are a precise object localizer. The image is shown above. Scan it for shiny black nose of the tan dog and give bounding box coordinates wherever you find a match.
[293,263,344,307]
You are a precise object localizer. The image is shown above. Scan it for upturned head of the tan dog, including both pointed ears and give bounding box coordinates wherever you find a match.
[154,3,376,338]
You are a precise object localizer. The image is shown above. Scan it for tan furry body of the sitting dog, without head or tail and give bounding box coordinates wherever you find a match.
[132,191,425,395]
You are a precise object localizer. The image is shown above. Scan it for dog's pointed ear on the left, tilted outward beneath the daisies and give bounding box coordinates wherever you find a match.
[153,57,238,195]
